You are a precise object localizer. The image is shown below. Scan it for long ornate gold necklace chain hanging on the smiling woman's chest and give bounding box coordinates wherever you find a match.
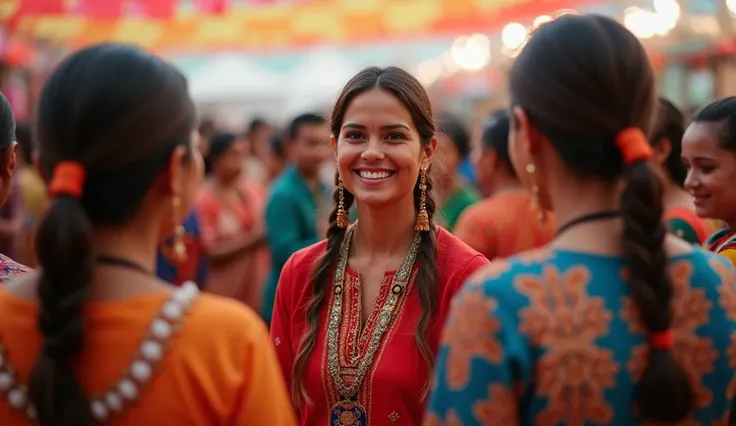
[327,226,421,399]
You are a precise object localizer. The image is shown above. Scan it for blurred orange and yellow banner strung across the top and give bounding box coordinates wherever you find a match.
[0,0,591,51]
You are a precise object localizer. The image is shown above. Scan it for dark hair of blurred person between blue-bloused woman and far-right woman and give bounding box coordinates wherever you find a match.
[649,98,687,186]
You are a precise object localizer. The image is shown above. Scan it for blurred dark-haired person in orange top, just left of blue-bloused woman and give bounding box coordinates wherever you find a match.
[455,111,555,260]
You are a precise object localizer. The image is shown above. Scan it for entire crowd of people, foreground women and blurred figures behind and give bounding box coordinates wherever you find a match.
[0,15,736,426]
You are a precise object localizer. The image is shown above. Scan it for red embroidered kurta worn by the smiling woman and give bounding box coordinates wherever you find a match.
[271,228,489,426]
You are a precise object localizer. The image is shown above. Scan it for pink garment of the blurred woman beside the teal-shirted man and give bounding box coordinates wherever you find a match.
[195,180,270,312]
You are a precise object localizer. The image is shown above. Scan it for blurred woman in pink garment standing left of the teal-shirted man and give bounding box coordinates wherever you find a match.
[195,133,268,312]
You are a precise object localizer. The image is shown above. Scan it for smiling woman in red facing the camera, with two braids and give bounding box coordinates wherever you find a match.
[271,67,488,426]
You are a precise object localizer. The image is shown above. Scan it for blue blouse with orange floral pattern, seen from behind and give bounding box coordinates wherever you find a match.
[425,249,736,426]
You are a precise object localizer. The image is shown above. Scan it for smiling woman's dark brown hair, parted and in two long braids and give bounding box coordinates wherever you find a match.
[291,67,438,405]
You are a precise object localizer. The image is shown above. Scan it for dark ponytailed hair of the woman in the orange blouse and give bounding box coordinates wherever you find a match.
[29,44,194,426]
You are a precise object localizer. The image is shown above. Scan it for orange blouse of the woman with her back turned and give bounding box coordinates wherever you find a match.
[0,287,296,426]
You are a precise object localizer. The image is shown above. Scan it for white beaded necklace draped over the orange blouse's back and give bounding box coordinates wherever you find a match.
[0,282,199,422]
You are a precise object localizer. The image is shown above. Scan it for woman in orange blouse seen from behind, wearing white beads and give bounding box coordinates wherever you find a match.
[0,44,294,426]
